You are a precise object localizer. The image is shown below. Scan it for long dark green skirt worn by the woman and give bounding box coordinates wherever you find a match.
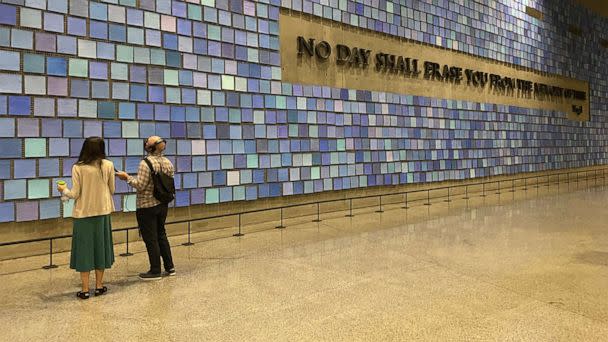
[70,215,114,272]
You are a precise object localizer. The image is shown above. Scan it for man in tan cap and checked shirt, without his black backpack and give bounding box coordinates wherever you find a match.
[116,136,175,280]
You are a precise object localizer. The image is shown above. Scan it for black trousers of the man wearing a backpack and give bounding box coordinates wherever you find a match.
[136,204,174,273]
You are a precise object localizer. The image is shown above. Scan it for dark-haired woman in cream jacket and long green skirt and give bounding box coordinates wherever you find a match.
[57,137,114,299]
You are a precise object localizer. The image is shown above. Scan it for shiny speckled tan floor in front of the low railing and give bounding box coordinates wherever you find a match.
[0,180,608,342]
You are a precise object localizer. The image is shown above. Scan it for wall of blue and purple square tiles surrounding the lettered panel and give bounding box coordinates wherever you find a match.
[0,0,608,222]
